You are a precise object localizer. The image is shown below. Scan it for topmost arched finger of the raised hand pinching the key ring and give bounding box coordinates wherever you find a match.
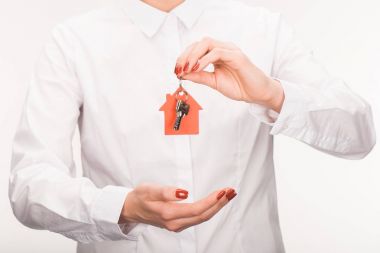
[183,37,237,74]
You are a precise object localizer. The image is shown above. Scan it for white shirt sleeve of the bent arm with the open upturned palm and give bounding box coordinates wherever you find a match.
[9,24,143,243]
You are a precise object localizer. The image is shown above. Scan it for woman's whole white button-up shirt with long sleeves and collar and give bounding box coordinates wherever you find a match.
[9,0,375,253]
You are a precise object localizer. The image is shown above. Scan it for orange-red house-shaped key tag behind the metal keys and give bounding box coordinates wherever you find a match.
[160,87,202,135]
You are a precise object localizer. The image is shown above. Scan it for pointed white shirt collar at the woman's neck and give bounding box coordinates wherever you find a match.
[121,0,215,37]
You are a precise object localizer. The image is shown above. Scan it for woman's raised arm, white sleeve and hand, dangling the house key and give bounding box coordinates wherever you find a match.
[180,13,375,159]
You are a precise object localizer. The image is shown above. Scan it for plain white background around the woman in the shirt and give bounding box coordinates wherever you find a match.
[0,0,380,253]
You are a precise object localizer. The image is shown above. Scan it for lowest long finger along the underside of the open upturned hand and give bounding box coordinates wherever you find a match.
[165,189,237,232]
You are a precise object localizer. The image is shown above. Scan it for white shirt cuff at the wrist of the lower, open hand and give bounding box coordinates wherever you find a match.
[91,185,147,241]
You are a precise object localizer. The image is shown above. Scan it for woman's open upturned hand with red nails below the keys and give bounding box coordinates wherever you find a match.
[119,183,236,232]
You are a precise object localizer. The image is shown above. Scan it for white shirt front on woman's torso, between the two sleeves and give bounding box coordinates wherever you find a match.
[67,0,284,253]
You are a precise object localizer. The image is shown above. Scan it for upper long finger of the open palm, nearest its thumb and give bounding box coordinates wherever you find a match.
[156,186,233,221]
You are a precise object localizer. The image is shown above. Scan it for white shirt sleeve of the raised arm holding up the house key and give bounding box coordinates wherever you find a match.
[249,15,376,159]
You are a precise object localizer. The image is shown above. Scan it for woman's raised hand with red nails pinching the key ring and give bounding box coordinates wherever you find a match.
[174,37,284,112]
